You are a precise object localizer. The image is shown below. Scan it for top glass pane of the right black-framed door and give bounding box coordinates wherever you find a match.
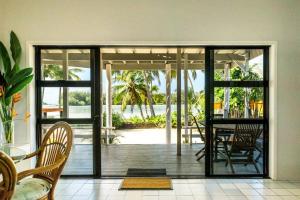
[214,49,263,81]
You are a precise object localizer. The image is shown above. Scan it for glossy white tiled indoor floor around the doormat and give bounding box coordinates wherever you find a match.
[56,179,300,200]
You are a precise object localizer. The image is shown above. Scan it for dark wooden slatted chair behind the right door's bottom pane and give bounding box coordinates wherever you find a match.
[225,124,262,173]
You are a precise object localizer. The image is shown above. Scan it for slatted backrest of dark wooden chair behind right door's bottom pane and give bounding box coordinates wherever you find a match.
[232,124,262,153]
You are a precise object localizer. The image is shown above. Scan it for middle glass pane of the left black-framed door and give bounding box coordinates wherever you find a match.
[42,87,91,118]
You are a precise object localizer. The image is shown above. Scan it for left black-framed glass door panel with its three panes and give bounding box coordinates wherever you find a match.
[35,46,100,175]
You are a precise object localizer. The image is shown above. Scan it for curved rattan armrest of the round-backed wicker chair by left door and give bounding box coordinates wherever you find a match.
[18,156,66,181]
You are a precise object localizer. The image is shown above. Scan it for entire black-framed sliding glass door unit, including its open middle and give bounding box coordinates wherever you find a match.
[35,46,269,177]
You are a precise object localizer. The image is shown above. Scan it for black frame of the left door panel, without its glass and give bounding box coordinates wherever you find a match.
[34,45,102,178]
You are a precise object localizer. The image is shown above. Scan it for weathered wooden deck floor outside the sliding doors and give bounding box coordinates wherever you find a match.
[63,144,262,176]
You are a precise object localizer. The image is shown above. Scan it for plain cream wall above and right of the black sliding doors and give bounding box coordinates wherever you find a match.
[0,0,300,180]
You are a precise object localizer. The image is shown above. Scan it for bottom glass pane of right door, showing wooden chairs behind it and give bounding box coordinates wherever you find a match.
[211,124,263,174]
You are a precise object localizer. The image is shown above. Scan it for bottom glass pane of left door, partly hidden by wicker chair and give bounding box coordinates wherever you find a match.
[42,124,93,175]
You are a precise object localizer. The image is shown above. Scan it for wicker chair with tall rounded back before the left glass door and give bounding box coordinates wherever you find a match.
[13,122,73,200]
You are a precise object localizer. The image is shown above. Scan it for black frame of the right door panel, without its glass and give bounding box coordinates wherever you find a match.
[205,45,270,178]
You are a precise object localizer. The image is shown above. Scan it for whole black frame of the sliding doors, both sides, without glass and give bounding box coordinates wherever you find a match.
[34,45,270,178]
